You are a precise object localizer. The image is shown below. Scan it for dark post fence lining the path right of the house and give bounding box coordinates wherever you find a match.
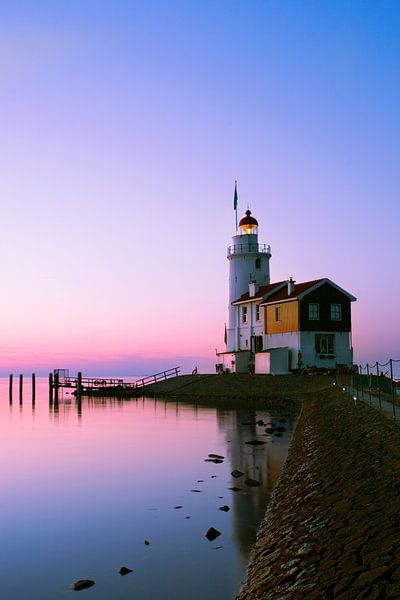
[335,358,400,420]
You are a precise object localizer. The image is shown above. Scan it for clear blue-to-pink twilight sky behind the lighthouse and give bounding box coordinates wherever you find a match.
[0,0,400,375]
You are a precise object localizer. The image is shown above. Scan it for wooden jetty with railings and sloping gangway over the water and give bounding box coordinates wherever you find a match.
[49,367,181,398]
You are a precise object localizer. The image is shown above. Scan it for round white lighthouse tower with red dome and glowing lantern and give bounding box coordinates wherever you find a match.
[226,210,271,352]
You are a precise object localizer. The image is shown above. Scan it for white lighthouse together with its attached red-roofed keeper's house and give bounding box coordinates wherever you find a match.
[217,210,356,374]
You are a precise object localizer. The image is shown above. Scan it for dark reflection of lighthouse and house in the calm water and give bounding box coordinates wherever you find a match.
[217,409,297,563]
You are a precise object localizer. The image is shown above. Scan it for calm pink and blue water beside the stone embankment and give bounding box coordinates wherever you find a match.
[0,379,296,600]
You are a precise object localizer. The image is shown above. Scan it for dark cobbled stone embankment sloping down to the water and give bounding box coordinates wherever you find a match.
[237,385,400,600]
